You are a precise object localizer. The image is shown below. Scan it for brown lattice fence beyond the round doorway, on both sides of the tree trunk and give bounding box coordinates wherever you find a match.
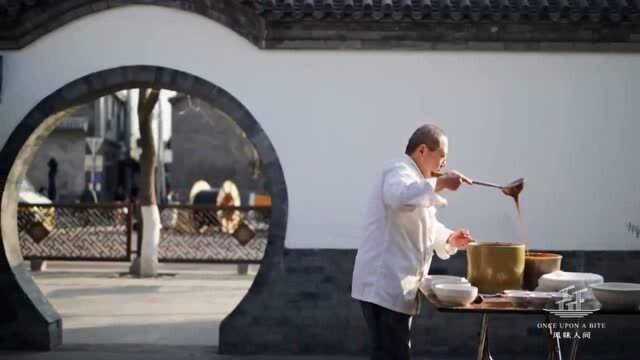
[18,204,270,263]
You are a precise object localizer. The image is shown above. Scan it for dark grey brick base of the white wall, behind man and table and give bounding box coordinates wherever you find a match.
[220,249,640,359]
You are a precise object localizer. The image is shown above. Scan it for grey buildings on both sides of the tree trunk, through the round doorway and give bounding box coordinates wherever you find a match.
[27,89,265,204]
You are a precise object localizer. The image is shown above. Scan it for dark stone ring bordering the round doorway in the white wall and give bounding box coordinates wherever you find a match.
[0,65,288,350]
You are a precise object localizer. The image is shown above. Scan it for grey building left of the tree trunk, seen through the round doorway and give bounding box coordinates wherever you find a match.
[27,91,130,203]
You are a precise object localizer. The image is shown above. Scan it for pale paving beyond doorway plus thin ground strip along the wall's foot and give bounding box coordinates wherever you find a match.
[0,262,460,360]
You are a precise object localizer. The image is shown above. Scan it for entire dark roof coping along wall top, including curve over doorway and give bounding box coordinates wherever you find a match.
[0,0,640,52]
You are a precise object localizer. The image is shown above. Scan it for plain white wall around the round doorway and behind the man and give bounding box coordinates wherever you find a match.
[0,6,640,249]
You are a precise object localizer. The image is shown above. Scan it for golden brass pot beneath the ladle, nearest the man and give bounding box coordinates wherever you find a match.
[467,243,525,294]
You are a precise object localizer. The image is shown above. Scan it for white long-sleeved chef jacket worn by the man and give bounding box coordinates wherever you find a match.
[351,155,457,315]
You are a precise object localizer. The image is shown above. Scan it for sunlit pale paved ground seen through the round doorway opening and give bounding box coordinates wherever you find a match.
[29,262,257,346]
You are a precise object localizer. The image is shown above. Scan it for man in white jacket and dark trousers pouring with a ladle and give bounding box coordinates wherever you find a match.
[351,125,472,360]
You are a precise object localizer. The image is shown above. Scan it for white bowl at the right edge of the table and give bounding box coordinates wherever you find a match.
[591,282,640,310]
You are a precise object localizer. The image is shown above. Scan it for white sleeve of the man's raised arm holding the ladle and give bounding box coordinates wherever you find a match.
[382,166,442,209]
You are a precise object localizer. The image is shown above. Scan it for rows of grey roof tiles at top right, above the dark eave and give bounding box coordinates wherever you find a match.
[253,0,640,23]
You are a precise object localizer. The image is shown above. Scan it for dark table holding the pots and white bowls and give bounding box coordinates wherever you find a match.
[427,295,616,360]
